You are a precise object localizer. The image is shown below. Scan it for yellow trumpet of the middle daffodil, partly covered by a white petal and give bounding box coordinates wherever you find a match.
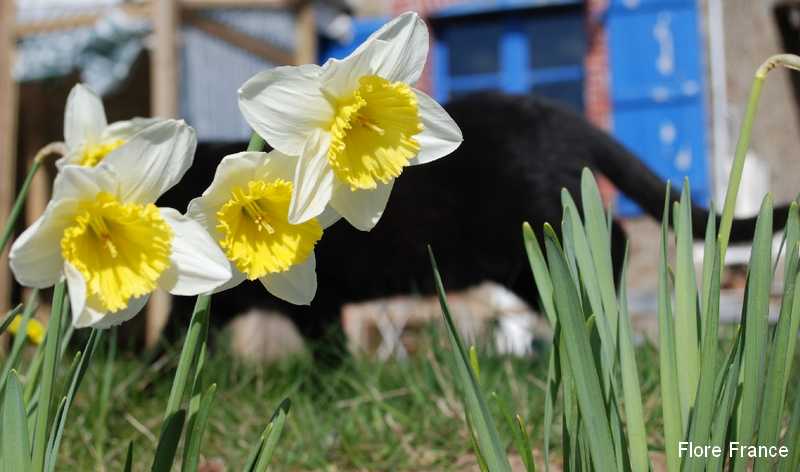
[216,179,322,280]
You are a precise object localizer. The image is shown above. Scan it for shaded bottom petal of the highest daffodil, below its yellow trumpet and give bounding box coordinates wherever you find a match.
[331,181,394,231]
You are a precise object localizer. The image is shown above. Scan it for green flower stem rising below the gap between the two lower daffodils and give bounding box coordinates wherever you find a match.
[164,295,211,421]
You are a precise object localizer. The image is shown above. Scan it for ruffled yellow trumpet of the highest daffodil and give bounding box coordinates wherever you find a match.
[328,75,423,190]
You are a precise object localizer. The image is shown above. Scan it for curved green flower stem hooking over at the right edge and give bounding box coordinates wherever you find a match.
[718,54,800,268]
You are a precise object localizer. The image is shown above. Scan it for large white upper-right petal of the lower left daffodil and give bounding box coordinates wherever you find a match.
[107,120,197,203]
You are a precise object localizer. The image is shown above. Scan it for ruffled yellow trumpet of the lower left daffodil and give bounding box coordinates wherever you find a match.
[61,192,173,312]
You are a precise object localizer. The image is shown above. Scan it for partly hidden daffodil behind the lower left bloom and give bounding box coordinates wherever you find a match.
[56,84,163,169]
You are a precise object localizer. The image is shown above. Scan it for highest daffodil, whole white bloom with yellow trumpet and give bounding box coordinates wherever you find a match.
[239,13,462,230]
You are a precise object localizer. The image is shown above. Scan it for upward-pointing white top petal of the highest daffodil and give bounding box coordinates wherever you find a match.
[352,12,429,85]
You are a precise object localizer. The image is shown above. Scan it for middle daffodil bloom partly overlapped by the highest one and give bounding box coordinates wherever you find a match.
[187,151,339,305]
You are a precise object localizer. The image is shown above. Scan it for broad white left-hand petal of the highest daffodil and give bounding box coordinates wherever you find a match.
[239,65,333,156]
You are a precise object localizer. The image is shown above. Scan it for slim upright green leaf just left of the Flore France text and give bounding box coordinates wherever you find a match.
[658,188,683,472]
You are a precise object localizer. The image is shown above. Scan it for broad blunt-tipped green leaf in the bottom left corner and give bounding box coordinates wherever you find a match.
[0,371,31,472]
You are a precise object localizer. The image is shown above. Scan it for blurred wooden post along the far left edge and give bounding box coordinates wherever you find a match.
[0,0,18,313]
